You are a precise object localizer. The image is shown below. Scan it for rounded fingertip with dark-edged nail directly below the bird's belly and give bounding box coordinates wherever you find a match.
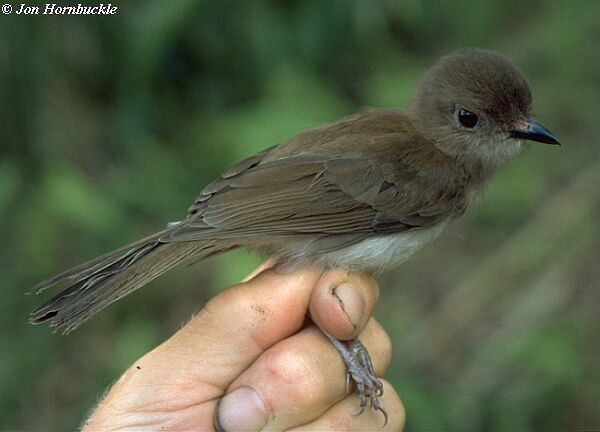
[310,270,379,340]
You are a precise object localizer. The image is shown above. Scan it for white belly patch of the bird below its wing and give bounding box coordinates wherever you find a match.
[319,223,446,271]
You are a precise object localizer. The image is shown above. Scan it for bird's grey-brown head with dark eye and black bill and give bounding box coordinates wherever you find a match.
[408,49,559,172]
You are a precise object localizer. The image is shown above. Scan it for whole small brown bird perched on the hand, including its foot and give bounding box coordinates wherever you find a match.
[31,49,559,422]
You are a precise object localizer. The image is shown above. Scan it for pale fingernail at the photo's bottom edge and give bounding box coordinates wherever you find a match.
[215,386,269,431]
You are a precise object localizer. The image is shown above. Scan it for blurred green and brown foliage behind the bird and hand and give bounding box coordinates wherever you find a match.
[0,0,600,430]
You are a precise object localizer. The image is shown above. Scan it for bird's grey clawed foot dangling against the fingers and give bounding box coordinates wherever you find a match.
[323,332,388,427]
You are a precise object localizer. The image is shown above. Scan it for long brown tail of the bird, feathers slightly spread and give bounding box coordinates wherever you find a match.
[30,230,220,333]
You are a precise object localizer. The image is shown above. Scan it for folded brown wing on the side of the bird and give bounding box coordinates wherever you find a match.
[161,134,464,242]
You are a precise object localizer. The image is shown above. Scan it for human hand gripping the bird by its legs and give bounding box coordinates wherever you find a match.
[83,267,405,431]
